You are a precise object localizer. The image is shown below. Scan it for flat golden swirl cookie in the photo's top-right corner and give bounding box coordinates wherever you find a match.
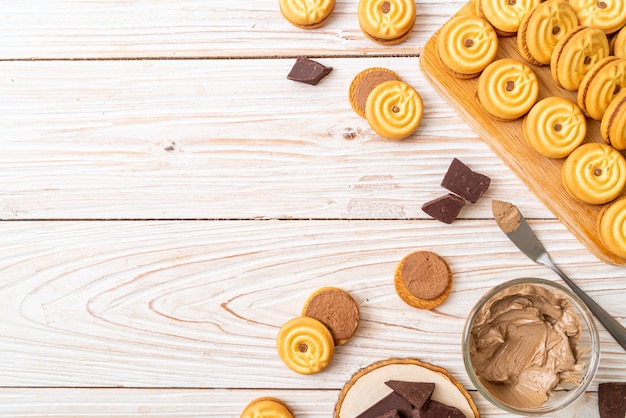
[569,0,626,34]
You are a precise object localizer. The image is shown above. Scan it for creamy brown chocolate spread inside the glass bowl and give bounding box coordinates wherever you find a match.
[470,284,582,408]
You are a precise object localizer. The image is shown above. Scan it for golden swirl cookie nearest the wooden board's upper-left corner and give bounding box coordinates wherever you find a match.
[437,16,498,79]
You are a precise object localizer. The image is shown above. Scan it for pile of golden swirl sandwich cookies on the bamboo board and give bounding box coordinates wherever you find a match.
[437,0,626,257]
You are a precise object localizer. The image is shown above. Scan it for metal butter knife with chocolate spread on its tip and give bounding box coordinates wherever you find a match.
[492,200,626,350]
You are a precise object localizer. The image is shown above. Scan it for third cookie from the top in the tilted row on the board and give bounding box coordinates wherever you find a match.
[578,55,626,120]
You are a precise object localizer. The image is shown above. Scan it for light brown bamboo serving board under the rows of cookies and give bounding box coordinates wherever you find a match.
[420,0,626,265]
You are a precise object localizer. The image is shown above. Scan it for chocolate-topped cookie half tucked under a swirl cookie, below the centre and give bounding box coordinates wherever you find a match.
[302,287,360,346]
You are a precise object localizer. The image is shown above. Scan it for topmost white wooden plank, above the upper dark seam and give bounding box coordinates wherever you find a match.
[0,0,465,59]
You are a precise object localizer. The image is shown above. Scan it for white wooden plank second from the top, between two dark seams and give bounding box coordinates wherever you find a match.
[0,58,553,219]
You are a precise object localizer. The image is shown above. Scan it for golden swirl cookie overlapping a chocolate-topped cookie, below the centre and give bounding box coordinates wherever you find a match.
[276,316,335,374]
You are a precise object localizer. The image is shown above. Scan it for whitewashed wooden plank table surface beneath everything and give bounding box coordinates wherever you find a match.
[0,0,626,418]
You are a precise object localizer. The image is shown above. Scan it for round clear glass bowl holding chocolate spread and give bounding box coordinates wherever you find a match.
[463,278,600,416]
